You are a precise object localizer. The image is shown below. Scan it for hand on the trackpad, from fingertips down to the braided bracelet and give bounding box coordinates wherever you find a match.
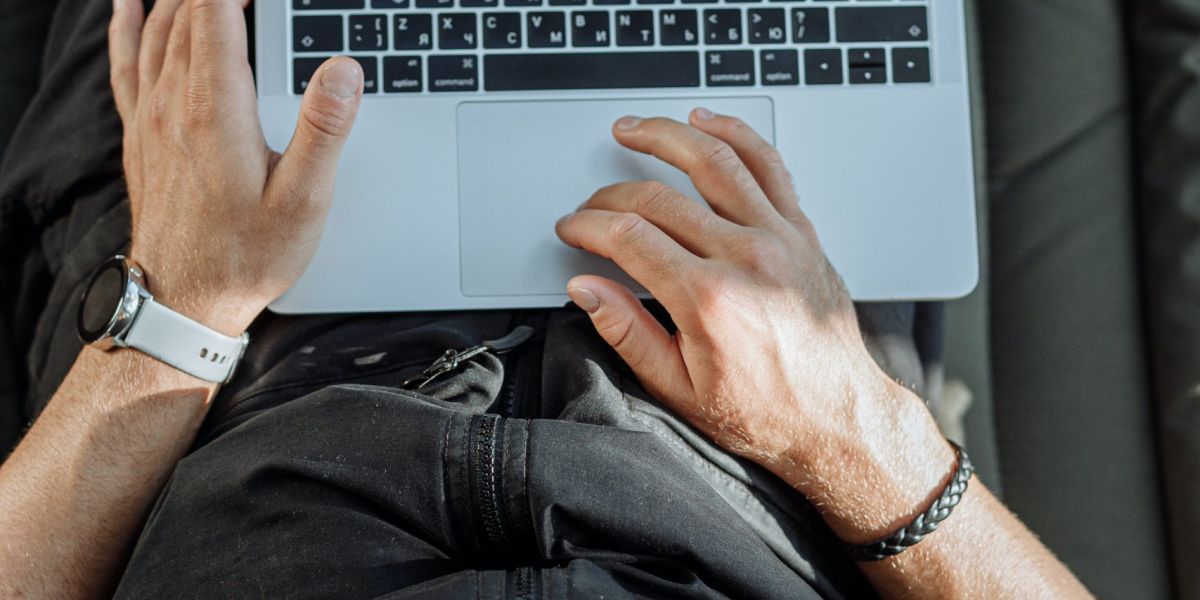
[558,109,954,536]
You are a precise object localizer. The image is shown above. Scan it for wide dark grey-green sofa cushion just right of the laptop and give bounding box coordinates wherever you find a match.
[977,0,1170,599]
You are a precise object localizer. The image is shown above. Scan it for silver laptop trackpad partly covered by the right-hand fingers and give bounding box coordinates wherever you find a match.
[458,97,774,296]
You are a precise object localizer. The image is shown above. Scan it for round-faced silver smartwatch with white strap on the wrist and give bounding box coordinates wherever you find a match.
[77,256,250,383]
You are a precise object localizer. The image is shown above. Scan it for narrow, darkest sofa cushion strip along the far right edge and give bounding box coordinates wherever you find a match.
[1133,0,1200,598]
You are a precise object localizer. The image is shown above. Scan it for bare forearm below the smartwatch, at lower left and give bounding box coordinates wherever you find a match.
[0,348,215,599]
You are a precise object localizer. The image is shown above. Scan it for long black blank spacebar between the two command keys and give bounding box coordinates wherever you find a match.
[484,52,700,91]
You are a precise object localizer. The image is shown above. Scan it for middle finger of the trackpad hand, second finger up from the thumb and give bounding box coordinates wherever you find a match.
[580,181,746,258]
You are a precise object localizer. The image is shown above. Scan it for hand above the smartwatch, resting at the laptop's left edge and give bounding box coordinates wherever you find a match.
[109,0,362,335]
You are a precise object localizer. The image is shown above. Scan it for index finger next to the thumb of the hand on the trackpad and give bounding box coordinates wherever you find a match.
[556,209,703,319]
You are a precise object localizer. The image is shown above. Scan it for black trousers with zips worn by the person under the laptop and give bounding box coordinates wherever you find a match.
[0,0,940,598]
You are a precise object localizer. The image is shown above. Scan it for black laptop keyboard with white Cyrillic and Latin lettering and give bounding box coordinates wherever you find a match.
[290,0,931,95]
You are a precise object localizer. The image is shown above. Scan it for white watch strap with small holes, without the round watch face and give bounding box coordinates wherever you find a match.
[125,298,246,383]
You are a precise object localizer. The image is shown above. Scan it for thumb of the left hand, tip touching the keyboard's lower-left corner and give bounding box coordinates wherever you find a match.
[271,56,362,211]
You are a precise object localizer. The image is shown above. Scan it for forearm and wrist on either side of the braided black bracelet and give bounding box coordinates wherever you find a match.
[779,383,1090,599]
